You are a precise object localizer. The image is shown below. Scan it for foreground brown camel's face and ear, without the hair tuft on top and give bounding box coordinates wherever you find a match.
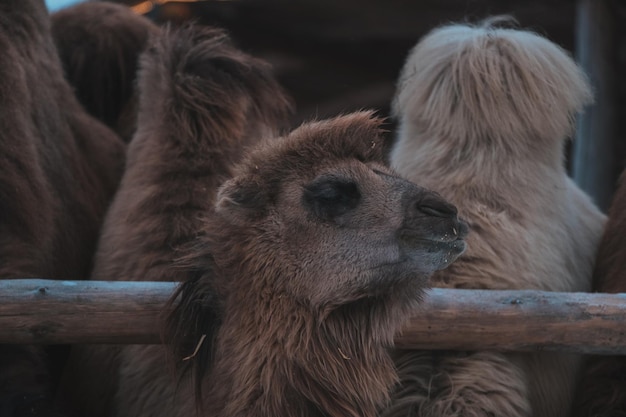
[218,132,468,307]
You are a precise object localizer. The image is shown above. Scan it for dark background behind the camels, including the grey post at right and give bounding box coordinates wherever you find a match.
[50,0,626,208]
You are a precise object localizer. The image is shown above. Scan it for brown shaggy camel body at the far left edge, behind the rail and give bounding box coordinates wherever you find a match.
[0,0,124,416]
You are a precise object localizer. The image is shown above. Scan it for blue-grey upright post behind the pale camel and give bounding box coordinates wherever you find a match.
[572,0,619,211]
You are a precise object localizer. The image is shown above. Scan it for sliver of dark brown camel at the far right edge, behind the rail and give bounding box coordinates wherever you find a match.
[573,171,626,417]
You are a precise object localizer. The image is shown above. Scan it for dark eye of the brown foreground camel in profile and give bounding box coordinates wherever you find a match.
[302,175,361,220]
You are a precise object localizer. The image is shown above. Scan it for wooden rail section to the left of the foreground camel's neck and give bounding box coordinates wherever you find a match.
[0,279,176,344]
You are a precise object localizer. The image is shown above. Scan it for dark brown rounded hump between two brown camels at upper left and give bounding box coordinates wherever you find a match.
[51,1,159,142]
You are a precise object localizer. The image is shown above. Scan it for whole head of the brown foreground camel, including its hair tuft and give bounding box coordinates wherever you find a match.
[216,112,467,309]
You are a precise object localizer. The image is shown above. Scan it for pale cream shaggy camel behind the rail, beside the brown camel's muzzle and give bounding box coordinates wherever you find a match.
[386,17,604,417]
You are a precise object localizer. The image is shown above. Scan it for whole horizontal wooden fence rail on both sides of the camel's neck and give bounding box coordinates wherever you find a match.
[0,279,626,354]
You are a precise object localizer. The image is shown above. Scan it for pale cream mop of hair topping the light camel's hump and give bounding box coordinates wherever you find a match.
[393,18,592,146]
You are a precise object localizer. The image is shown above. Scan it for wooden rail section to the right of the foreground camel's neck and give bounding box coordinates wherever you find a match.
[396,289,626,354]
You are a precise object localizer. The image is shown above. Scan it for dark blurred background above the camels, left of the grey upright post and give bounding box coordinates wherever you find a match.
[130,0,576,122]
